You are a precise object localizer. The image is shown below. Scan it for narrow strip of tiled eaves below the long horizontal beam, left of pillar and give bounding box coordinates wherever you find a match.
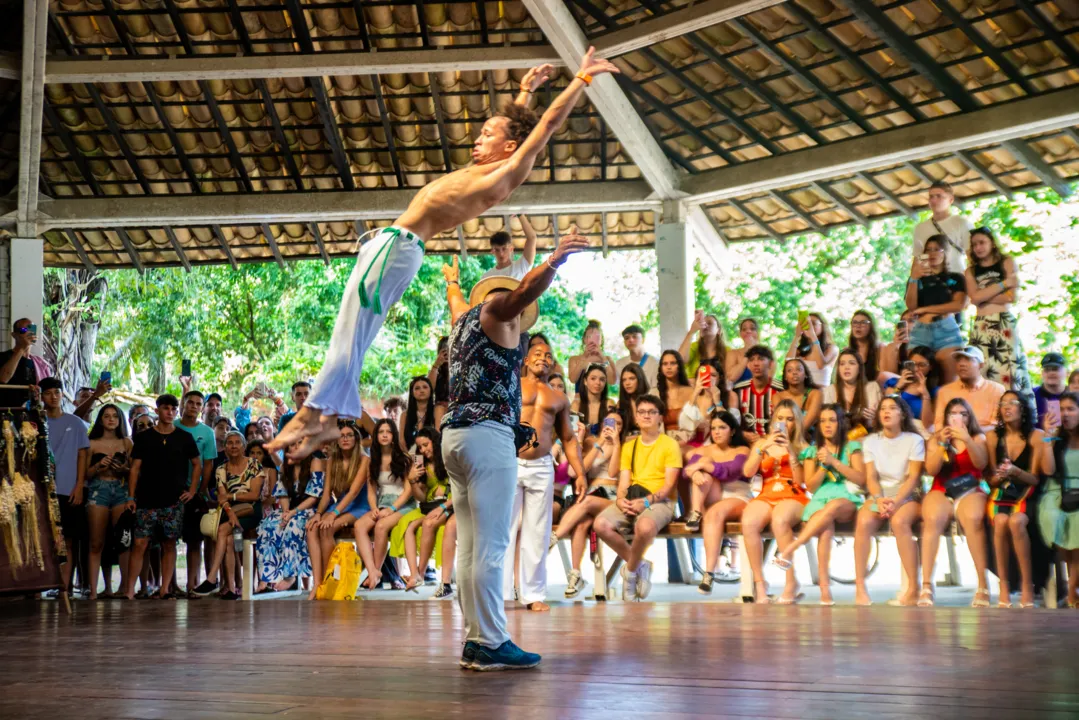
[39,212,654,268]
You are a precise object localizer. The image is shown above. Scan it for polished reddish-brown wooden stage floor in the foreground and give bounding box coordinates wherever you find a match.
[0,599,1079,720]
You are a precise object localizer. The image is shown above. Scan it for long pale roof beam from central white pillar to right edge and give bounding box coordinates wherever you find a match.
[682,87,1079,203]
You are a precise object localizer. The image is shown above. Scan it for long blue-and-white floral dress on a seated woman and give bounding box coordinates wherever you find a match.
[255,472,325,583]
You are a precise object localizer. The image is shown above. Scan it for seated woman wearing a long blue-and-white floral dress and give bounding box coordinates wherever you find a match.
[255,443,326,593]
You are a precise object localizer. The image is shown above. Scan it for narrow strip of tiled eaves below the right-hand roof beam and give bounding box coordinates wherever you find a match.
[707,128,1079,241]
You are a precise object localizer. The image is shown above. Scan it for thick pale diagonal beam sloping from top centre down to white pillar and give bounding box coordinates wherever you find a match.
[524,0,681,200]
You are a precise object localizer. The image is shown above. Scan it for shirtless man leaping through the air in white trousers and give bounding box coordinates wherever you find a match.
[267,47,618,460]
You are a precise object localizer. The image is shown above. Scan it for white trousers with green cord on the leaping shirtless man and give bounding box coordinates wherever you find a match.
[306,228,422,416]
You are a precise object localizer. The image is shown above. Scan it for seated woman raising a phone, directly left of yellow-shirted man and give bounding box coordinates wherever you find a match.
[550,408,625,599]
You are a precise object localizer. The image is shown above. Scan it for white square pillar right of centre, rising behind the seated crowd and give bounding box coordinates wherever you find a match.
[656,203,693,350]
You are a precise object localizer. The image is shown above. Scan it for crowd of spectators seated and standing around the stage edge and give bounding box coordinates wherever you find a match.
[14,184,1079,607]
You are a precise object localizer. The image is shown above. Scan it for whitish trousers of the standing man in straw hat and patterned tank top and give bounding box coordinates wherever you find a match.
[442,422,517,648]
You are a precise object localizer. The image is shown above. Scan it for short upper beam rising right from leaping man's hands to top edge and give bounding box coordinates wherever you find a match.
[595,0,783,57]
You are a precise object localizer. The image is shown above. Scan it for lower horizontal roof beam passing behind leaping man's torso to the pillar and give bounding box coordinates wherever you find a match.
[39,180,660,229]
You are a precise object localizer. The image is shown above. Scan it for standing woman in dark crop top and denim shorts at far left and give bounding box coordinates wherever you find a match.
[83,405,132,600]
